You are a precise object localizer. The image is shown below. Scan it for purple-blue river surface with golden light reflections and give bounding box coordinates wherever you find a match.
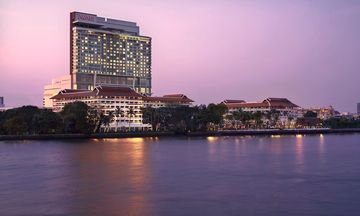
[0,134,360,216]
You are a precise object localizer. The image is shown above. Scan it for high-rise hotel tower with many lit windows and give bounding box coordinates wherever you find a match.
[70,12,151,95]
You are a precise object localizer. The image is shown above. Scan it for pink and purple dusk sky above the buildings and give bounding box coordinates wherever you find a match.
[0,0,360,112]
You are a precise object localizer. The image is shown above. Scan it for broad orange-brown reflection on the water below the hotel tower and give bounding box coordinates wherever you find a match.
[67,138,150,215]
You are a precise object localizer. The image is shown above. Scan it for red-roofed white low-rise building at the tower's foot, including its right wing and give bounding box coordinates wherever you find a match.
[51,86,193,131]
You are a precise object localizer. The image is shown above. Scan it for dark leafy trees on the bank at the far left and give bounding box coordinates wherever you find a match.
[0,102,114,135]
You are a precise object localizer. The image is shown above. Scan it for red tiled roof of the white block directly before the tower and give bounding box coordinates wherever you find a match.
[51,86,142,99]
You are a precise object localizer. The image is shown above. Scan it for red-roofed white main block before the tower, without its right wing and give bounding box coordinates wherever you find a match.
[51,86,151,131]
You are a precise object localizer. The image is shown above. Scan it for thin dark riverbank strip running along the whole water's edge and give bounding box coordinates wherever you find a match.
[0,128,360,140]
